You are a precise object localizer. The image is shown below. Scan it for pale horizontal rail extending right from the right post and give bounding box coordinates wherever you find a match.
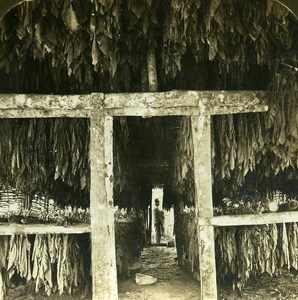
[212,211,298,226]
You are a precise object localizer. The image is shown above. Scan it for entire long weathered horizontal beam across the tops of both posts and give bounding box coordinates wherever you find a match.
[0,91,268,118]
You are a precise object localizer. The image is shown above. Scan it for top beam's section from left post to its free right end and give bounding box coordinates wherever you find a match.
[103,91,268,116]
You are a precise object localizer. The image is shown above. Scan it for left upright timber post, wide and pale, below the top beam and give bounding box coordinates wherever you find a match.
[90,116,118,300]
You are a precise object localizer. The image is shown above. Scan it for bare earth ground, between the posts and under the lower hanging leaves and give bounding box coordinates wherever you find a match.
[6,247,298,300]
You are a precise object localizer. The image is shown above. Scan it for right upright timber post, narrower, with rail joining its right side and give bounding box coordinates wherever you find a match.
[191,114,217,300]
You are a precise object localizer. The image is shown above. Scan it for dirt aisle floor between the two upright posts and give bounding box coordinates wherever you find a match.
[119,247,200,300]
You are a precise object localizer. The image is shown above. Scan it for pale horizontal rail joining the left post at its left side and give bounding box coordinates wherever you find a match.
[0,223,91,235]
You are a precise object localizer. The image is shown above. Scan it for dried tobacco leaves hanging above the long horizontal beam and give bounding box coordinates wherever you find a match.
[0,0,297,91]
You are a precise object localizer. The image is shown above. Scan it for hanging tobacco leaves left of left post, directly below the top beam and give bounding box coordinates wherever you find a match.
[0,118,90,206]
